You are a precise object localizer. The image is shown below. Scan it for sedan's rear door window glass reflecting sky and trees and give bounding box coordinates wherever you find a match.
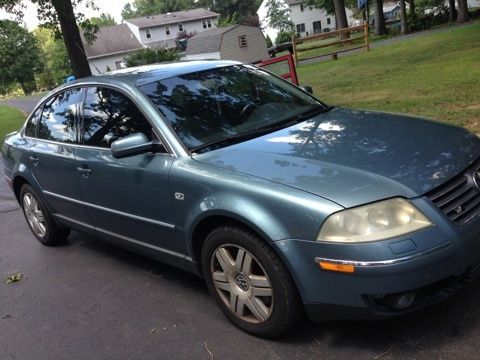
[37,88,82,143]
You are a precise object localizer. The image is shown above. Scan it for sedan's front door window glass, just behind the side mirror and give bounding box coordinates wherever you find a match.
[83,87,152,148]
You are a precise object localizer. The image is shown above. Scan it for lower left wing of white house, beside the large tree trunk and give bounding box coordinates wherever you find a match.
[83,24,143,75]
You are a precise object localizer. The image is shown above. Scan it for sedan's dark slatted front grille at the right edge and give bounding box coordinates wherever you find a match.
[427,161,480,224]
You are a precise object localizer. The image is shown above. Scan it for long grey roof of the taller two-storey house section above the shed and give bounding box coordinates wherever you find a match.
[125,8,220,29]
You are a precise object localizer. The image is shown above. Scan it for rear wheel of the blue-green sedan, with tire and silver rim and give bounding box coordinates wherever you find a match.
[20,184,70,246]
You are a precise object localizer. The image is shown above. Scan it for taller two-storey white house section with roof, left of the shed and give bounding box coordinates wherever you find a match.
[125,9,220,48]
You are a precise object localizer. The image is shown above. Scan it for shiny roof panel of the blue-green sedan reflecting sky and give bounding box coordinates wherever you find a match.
[70,60,241,86]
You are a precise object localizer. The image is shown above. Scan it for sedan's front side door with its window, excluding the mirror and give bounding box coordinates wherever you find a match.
[77,87,182,255]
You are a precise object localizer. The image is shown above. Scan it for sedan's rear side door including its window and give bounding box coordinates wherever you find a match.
[26,88,89,223]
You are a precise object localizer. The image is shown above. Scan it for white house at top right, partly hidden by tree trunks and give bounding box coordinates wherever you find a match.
[257,0,355,42]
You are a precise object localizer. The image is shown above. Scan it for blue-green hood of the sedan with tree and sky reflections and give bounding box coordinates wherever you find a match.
[194,108,480,207]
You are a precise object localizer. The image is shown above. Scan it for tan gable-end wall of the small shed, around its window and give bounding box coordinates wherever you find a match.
[220,25,269,63]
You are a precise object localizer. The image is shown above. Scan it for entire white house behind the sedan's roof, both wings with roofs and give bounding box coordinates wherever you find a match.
[82,9,219,75]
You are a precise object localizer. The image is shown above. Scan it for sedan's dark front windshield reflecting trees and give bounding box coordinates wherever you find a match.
[140,65,323,150]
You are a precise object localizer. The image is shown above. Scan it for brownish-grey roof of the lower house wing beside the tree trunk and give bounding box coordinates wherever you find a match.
[82,24,143,58]
